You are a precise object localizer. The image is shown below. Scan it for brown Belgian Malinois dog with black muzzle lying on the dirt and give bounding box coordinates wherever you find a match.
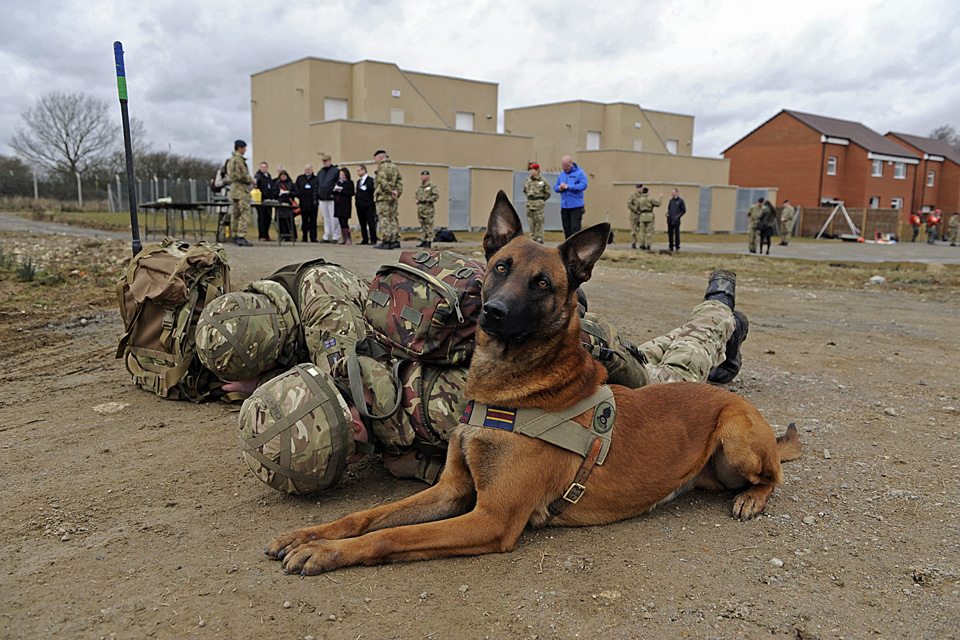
[265,191,800,575]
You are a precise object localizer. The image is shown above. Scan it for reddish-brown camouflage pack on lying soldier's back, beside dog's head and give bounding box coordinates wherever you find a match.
[363,251,485,364]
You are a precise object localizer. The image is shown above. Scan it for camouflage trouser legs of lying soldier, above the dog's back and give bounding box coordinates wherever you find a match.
[639,300,736,384]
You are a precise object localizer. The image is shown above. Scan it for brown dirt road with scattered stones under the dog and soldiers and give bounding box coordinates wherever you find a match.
[0,226,960,640]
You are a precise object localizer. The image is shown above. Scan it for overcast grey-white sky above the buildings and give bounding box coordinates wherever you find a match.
[0,0,960,168]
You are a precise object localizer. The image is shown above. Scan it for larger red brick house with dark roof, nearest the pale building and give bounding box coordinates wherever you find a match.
[723,109,921,211]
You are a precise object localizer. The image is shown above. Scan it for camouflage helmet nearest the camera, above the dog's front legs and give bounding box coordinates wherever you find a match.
[240,364,353,494]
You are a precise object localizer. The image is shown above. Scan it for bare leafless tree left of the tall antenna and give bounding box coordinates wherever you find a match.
[10,91,119,175]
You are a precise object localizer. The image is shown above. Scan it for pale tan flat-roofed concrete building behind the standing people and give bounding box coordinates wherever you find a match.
[251,58,737,232]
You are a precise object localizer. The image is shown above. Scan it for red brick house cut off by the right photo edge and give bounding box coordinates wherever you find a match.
[887,131,960,214]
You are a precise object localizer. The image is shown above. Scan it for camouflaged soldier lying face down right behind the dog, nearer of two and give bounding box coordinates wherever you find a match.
[227,271,748,493]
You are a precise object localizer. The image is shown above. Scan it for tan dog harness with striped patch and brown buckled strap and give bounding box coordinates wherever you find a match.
[460,385,617,524]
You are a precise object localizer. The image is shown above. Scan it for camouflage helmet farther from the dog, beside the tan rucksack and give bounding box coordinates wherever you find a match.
[196,282,299,381]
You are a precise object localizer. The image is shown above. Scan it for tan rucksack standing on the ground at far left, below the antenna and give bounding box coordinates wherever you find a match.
[117,237,230,402]
